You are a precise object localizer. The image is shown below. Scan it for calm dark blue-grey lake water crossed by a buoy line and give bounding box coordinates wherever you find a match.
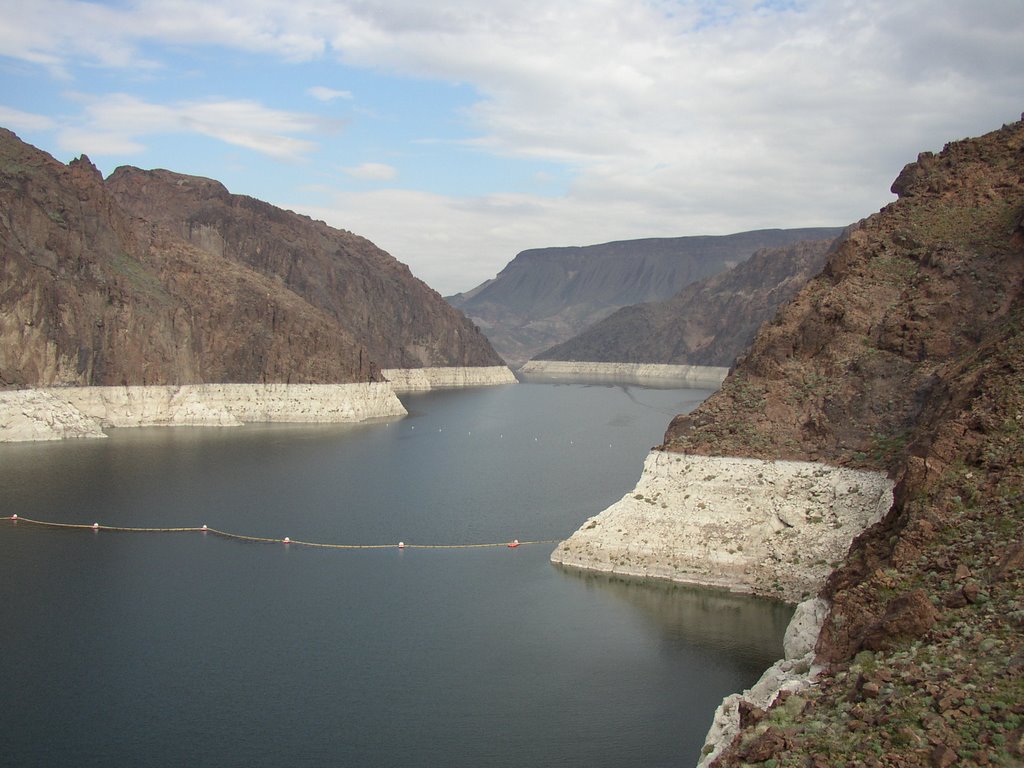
[0,384,791,768]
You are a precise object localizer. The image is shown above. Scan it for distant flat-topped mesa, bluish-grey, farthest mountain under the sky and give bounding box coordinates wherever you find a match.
[447,227,842,366]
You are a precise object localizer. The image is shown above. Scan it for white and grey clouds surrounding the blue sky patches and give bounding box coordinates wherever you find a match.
[0,0,1024,292]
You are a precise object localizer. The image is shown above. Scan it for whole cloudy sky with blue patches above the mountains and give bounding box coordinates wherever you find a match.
[0,0,1024,294]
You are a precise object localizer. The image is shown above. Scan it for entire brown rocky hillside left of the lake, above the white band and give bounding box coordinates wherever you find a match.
[0,129,503,386]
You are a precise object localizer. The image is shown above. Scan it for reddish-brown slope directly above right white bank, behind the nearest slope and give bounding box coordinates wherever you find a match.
[665,119,1024,469]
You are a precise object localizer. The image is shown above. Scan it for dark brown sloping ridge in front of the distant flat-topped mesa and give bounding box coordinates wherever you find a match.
[534,240,833,368]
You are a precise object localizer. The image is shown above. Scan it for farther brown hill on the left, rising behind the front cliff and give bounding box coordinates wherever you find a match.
[108,167,503,368]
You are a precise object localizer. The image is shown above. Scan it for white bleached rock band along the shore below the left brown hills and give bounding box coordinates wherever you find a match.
[0,366,516,443]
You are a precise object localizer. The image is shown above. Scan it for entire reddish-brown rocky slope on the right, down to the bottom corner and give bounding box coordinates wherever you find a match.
[663,117,1024,766]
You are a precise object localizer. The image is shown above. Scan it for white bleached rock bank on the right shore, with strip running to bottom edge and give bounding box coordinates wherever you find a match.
[551,451,893,768]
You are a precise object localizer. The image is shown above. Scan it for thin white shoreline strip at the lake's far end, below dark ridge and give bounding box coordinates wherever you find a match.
[519,360,729,389]
